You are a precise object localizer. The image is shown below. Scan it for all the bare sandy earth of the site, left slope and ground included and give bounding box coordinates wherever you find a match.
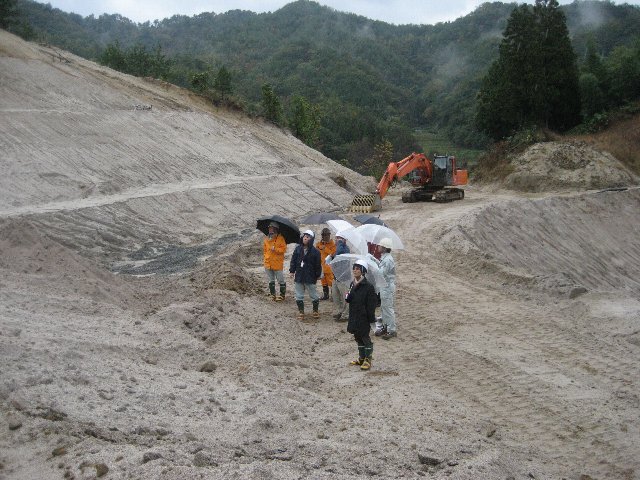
[0,32,640,480]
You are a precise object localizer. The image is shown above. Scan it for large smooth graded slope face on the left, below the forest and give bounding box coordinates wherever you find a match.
[0,31,371,262]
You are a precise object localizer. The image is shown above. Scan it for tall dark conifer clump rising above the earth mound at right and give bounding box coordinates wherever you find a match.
[476,0,580,140]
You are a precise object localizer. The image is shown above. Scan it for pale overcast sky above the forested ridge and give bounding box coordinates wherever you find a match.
[39,0,640,25]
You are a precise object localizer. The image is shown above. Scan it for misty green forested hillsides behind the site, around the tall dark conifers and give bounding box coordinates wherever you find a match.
[7,0,640,171]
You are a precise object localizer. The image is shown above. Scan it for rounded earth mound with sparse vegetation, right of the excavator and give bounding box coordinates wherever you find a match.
[505,141,638,192]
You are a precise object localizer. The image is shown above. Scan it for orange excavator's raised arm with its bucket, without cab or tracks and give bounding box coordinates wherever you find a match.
[350,153,433,213]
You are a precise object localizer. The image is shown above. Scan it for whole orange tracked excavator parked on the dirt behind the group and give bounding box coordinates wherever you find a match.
[349,152,468,213]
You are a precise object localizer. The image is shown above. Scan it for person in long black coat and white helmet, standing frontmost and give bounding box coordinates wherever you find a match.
[346,260,377,370]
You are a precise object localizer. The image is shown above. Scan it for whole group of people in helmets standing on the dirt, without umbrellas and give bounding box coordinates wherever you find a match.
[263,222,397,370]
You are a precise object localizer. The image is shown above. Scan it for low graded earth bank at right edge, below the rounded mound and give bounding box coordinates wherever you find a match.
[441,188,640,295]
